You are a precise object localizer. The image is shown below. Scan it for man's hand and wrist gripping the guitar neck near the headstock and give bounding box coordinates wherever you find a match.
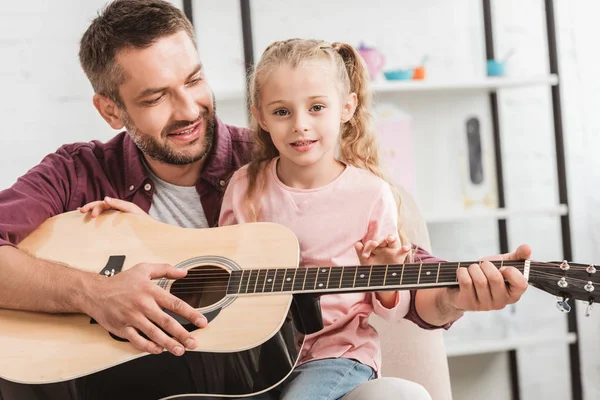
[415,245,531,326]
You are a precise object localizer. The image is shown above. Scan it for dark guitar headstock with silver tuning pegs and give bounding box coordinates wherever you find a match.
[529,261,600,315]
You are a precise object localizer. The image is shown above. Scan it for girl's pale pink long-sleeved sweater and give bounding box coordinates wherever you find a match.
[219,160,410,371]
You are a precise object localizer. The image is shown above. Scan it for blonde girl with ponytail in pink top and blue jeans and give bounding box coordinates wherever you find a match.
[219,39,429,400]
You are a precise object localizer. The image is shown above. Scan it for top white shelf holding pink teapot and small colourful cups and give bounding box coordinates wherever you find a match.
[372,74,558,93]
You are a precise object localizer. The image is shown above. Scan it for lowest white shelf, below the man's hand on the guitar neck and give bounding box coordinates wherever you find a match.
[445,332,577,357]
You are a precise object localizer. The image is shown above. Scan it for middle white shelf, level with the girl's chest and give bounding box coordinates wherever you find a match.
[425,204,568,224]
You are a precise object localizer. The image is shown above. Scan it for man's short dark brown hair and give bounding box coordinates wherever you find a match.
[79,0,195,107]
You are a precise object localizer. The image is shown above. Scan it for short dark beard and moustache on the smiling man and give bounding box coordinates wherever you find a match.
[121,103,216,165]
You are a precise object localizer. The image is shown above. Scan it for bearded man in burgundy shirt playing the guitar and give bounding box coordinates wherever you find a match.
[0,0,529,400]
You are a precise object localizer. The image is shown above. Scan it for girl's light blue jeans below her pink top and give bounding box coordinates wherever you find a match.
[240,358,375,400]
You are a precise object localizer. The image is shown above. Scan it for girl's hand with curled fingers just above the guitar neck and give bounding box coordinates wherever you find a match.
[354,235,410,265]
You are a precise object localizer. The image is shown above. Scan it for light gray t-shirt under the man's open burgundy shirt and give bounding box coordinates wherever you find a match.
[147,168,209,228]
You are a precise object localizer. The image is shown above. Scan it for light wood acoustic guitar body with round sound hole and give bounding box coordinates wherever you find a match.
[0,212,303,400]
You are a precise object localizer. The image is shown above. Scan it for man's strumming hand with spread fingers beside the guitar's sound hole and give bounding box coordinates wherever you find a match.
[83,263,207,356]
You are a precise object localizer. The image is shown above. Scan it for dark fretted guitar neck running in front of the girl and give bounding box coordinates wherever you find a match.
[227,261,529,296]
